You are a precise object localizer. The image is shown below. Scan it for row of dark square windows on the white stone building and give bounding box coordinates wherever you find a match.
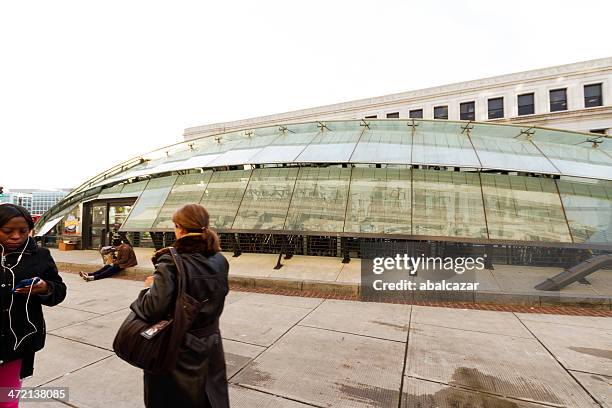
[365,84,603,120]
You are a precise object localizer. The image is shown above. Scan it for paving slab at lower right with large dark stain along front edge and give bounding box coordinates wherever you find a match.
[406,323,596,407]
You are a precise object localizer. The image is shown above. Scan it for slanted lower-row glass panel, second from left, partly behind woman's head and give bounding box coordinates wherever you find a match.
[153,170,213,231]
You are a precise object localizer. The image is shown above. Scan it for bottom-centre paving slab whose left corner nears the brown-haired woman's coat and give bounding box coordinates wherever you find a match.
[231,326,405,407]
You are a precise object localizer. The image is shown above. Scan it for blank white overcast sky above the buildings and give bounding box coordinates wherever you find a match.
[0,0,612,189]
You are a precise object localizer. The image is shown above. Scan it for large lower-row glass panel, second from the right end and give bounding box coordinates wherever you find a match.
[481,173,572,242]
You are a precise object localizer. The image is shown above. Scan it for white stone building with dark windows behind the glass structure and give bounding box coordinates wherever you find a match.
[184,58,612,140]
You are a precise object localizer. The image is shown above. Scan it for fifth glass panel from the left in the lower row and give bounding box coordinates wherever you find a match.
[284,167,351,232]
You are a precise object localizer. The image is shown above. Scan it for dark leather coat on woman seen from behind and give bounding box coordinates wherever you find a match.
[130,236,229,408]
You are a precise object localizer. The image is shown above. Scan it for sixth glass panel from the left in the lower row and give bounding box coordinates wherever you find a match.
[344,168,412,235]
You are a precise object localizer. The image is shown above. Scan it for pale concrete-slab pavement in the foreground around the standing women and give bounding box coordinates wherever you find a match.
[21,273,612,408]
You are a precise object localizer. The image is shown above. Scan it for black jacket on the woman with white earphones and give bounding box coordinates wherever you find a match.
[0,238,66,378]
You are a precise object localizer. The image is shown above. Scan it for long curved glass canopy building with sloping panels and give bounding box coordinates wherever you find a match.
[37,119,612,260]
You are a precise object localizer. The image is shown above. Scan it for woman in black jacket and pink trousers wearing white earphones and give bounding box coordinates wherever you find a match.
[0,204,66,407]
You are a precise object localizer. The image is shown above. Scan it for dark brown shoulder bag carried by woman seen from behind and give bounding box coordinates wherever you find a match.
[113,247,205,374]
